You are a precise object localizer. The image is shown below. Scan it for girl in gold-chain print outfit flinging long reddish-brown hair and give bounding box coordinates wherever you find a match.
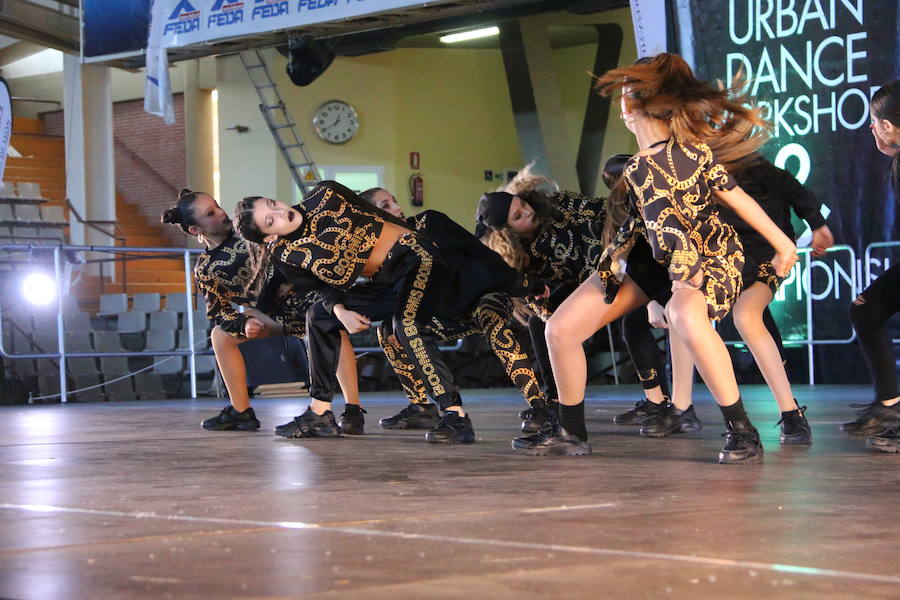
[520,53,797,463]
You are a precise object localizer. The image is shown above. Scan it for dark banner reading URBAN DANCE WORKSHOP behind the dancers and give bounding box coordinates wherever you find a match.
[681,0,900,339]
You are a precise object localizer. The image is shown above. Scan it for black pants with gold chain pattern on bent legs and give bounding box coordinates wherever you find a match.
[378,292,540,405]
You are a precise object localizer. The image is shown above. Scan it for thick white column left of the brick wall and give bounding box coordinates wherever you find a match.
[63,54,116,246]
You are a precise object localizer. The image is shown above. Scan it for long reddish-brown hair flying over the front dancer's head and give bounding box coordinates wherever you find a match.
[596,52,769,170]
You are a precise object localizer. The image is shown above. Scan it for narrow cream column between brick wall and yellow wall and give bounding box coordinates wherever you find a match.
[179,59,213,194]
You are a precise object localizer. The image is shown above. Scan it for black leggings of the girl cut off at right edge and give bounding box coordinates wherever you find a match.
[850,264,900,402]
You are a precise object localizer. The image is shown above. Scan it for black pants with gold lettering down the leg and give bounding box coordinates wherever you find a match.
[306,236,462,409]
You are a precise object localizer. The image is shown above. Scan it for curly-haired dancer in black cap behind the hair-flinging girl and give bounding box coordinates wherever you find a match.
[476,161,676,433]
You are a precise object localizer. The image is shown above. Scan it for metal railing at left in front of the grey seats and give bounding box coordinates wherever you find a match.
[0,244,208,402]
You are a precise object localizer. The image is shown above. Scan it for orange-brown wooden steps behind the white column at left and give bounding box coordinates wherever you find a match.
[4,118,190,311]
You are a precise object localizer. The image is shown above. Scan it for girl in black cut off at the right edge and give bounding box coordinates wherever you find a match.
[841,80,900,452]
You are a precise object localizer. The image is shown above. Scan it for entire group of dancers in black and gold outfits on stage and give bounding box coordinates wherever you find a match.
[162,53,900,464]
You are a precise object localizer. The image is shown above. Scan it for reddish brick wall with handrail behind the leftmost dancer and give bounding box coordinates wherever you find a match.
[42,94,187,247]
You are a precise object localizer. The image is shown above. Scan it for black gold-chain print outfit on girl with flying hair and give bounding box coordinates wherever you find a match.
[598,138,744,320]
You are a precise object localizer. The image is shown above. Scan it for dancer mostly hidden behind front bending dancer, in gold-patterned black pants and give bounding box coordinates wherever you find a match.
[360,188,550,433]
